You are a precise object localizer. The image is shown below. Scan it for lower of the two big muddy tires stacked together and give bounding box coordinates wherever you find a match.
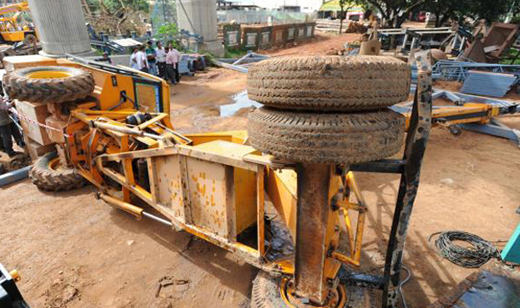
[247,107,405,164]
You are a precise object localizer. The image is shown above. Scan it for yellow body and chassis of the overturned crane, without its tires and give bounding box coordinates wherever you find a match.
[4,57,374,279]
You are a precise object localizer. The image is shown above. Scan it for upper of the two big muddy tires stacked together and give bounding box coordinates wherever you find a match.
[247,56,411,111]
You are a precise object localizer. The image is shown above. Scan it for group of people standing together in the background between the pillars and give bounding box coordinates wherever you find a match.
[130,41,181,84]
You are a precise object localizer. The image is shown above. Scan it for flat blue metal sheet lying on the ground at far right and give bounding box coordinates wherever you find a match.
[460,71,517,97]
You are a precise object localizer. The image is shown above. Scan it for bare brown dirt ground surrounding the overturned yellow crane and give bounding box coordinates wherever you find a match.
[0,35,520,308]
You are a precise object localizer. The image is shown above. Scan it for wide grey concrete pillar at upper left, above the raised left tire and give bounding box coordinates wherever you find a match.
[29,0,92,56]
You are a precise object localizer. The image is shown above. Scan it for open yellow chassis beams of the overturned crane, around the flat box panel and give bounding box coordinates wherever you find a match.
[63,109,372,275]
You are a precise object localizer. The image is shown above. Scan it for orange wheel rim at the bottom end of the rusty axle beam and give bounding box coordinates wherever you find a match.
[280,278,347,308]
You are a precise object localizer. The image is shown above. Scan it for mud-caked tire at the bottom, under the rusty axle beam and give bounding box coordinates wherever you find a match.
[251,271,375,308]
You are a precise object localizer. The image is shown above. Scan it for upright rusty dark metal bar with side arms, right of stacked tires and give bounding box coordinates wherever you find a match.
[340,52,432,308]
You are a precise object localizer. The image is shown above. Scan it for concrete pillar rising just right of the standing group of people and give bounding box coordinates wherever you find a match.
[175,0,224,56]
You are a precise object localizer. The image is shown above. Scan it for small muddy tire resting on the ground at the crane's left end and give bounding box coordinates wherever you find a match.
[29,152,87,191]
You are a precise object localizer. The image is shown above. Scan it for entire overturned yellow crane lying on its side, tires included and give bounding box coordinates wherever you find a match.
[4,54,431,307]
